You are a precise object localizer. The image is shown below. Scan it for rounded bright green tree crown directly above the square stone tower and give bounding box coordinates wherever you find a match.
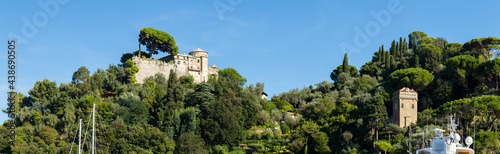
[388,68,434,90]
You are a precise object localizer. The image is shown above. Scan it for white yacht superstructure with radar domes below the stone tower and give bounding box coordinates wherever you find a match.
[417,116,474,154]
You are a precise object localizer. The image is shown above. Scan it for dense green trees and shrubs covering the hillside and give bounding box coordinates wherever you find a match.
[0,28,500,154]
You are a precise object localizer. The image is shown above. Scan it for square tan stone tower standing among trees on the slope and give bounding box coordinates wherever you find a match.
[392,87,418,127]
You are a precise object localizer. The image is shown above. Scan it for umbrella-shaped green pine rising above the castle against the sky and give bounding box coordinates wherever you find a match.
[139,27,179,58]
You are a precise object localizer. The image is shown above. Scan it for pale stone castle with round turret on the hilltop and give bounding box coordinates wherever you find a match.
[132,48,219,83]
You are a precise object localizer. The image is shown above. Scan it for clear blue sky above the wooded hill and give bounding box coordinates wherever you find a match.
[0,0,500,121]
